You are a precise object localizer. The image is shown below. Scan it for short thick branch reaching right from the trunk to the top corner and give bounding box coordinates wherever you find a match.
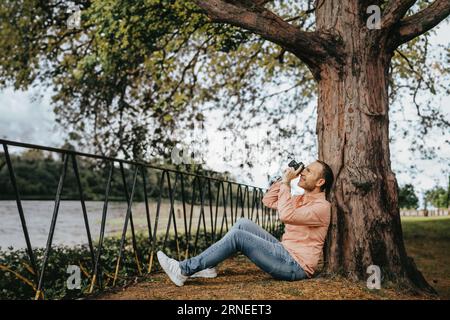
[394,0,450,46]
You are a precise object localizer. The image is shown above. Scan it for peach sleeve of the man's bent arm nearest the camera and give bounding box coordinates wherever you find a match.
[278,185,330,227]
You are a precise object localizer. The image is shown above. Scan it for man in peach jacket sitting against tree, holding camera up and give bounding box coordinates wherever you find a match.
[157,160,333,286]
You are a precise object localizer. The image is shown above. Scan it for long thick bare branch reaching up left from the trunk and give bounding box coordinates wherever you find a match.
[194,0,340,72]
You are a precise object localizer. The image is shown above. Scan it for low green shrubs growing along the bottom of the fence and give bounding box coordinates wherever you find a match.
[0,232,220,299]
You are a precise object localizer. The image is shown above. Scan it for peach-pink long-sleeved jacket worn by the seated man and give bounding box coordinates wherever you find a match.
[262,181,331,278]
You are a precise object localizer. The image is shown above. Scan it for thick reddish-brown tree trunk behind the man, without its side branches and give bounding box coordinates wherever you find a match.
[316,1,435,293]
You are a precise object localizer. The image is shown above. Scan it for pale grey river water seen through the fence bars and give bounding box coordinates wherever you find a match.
[0,201,230,250]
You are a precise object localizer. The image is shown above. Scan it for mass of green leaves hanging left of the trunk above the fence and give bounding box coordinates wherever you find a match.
[0,0,314,168]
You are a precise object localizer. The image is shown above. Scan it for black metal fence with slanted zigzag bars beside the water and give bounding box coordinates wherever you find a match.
[0,139,280,299]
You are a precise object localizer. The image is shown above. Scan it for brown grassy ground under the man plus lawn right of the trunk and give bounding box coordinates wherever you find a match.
[98,217,450,300]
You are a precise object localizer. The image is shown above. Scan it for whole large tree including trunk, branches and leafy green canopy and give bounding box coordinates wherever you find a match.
[0,0,450,290]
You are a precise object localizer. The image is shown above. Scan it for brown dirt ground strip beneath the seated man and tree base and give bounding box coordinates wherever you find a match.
[95,255,439,300]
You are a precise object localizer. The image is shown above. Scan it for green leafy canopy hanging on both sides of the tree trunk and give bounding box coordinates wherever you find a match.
[0,0,449,181]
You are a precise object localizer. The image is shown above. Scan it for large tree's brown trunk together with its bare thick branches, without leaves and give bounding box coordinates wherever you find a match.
[195,0,450,289]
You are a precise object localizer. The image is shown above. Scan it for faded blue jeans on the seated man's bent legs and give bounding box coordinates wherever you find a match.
[180,218,307,281]
